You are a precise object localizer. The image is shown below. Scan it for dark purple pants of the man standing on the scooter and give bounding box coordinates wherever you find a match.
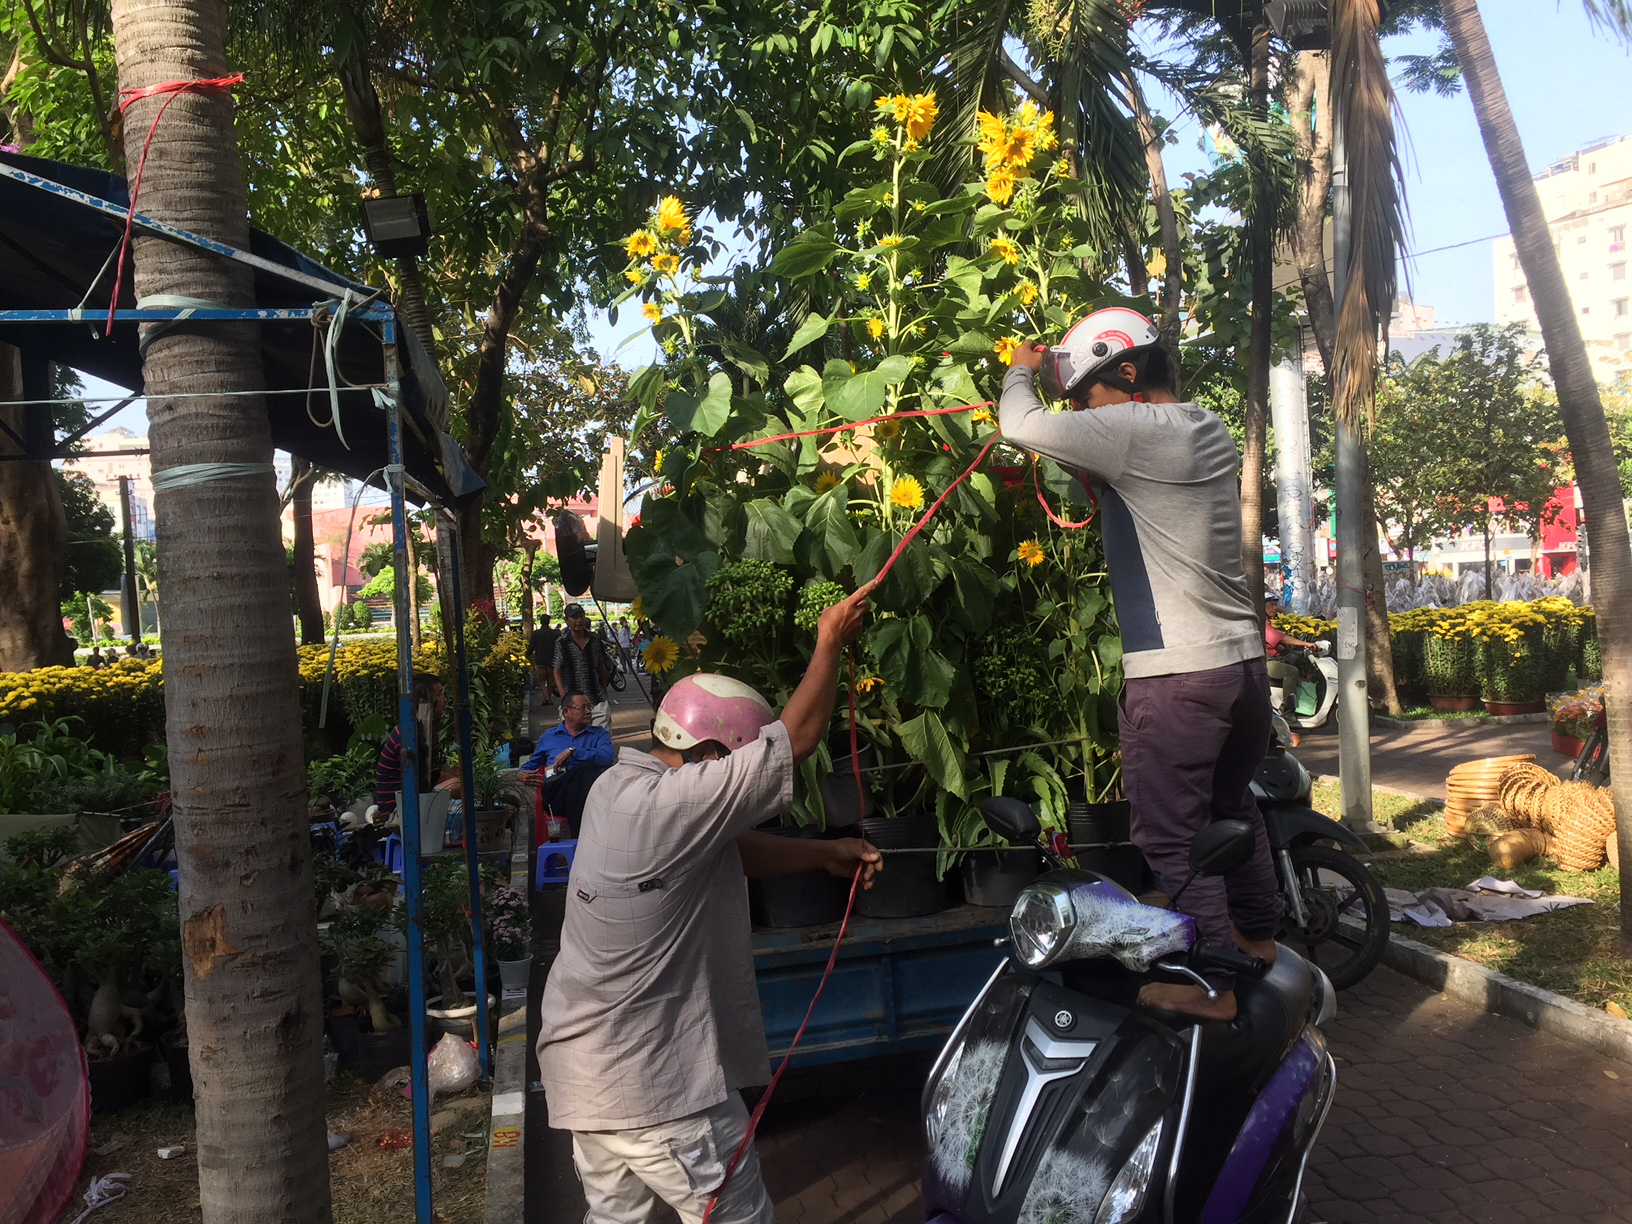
[1118,659,1281,987]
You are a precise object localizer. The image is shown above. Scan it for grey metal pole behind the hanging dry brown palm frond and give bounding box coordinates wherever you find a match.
[1332,108,1371,831]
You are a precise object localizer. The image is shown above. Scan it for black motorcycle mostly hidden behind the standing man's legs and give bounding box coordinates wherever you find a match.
[1252,713,1389,991]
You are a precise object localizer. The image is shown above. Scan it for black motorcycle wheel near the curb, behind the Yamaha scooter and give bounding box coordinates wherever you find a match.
[1279,845,1389,991]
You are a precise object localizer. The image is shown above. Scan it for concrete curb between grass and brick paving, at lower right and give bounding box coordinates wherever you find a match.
[1382,935,1632,1062]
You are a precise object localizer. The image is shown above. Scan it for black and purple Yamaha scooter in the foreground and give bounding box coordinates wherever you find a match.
[922,798,1337,1224]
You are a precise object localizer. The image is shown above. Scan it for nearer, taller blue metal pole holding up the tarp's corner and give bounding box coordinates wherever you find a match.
[384,322,431,1224]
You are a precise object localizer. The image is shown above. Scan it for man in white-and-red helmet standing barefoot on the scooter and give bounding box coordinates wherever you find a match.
[999,307,1281,1020]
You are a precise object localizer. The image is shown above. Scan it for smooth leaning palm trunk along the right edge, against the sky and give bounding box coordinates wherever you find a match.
[1439,0,1632,956]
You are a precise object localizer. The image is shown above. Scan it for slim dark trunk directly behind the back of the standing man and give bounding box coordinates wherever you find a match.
[1240,26,1275,620]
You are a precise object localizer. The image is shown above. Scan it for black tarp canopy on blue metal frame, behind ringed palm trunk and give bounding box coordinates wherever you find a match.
[0,152,483,506]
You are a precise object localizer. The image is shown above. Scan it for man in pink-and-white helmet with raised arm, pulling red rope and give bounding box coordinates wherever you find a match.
[537,586,881,1224]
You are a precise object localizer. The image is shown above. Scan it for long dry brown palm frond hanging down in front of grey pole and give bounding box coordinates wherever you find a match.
[1332,0,1405,426]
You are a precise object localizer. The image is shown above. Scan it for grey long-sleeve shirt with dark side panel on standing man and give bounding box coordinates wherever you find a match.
[999,366,1263,679]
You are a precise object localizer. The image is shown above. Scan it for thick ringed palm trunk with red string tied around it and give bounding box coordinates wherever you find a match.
[113,0,331,1224]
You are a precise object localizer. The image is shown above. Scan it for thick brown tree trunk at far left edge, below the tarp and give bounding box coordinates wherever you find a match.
[0,344,73,671]
